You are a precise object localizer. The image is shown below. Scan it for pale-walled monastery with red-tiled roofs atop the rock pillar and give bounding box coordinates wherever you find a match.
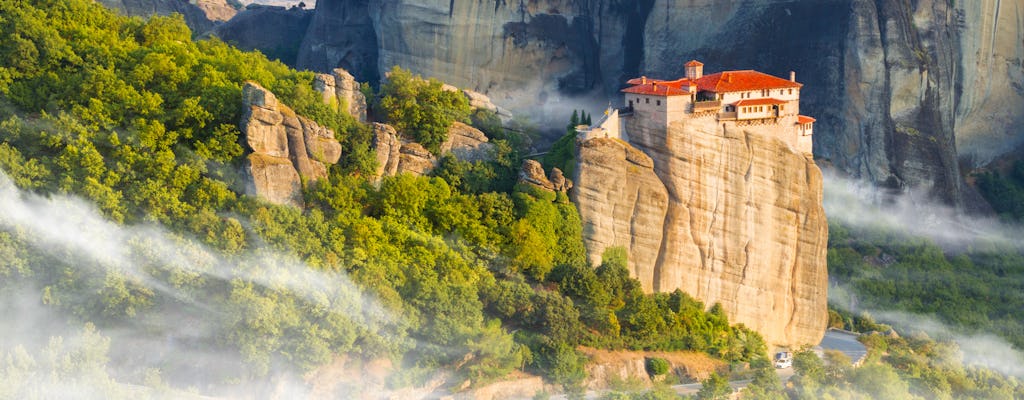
[577,59,815,155]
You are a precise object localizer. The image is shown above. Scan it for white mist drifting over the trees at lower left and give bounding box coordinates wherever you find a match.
[0,172,410,399]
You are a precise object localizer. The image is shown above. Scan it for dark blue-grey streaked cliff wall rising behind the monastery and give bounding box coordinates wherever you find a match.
[282,0,1024,205]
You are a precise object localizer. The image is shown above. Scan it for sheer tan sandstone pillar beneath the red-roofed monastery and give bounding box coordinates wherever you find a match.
[572,118,827,346]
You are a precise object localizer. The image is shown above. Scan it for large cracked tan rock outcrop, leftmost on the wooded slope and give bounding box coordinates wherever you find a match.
[240,82,341,207]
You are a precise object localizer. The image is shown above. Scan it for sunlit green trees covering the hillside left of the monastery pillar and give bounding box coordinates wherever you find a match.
[0,0,765,397]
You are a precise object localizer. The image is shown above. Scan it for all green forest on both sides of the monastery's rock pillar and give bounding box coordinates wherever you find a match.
[0,0,1024,398]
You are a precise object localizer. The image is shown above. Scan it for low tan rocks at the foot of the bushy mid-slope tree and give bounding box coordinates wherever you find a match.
[372,122,495,179]
